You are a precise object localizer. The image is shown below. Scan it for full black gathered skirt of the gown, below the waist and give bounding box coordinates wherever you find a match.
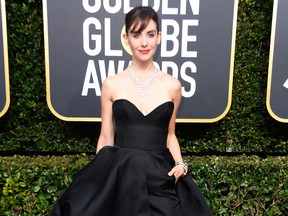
[50,146,211,216]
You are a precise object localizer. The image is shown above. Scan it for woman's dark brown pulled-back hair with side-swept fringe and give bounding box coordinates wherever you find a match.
[125,6,159,34]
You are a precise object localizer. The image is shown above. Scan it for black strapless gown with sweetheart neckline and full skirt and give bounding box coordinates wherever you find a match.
[51,99,211,216]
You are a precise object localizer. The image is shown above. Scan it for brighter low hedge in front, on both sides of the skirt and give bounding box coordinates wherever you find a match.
[0,155,288,216]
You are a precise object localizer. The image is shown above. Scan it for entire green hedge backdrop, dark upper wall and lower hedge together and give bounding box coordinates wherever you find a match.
[0,0,288,216]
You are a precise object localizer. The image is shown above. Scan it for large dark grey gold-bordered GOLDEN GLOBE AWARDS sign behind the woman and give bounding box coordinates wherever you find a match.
[43,0,238,122]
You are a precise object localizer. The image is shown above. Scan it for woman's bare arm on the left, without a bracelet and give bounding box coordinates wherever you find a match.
[96,78,115,154]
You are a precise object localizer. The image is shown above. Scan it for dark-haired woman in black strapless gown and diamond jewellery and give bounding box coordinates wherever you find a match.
[51,6,211,216]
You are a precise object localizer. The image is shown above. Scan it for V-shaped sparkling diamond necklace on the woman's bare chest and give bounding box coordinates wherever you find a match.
[127,66,158,97]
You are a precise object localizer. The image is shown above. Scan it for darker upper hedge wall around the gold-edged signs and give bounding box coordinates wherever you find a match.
[0,0,288,153]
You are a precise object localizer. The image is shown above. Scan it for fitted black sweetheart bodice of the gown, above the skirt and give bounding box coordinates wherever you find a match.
[113,99,174,149]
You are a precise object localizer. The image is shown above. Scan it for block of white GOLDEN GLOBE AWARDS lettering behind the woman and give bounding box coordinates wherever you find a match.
[81,0,200,98]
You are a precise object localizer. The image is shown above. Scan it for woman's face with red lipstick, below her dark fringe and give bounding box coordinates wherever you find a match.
[124,20,161,61]
